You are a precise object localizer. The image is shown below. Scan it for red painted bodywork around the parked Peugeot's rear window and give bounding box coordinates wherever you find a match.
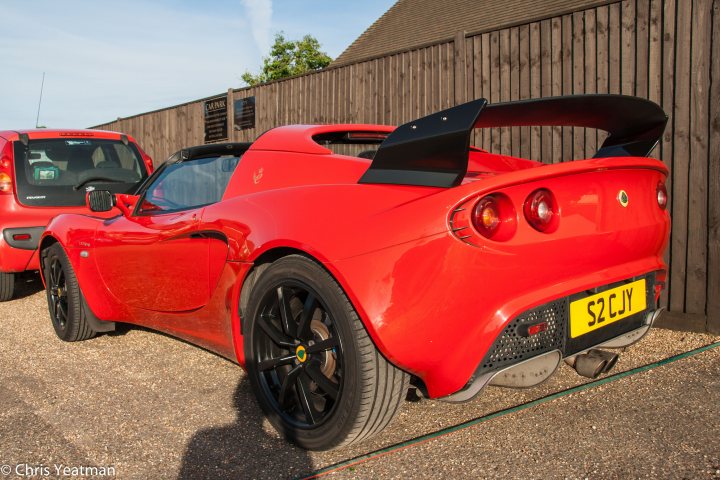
[0,129,152,272]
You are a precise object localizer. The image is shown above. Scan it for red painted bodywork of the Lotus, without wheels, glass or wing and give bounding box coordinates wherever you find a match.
[38,114,670,397]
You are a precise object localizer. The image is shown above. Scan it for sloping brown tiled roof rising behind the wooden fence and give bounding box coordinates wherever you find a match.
[332,0,611,65]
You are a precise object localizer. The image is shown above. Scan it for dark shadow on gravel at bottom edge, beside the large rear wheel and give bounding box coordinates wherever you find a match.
[178,375,313,480]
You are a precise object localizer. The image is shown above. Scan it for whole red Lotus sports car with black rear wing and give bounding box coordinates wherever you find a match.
[40,95,670,449]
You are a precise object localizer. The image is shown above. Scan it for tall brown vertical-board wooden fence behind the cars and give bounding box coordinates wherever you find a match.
[99,0,720,331]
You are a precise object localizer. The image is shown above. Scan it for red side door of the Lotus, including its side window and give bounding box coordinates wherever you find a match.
[94,154,231,312]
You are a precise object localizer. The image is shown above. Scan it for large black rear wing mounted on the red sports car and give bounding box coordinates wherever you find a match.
[359,95,668,187]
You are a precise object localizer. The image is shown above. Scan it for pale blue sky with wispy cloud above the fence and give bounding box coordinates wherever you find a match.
[0,0,395,130]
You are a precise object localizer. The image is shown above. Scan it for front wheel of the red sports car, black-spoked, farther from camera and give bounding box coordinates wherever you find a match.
[42,243,96,342]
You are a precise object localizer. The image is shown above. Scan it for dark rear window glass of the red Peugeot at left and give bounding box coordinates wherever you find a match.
[15,138,147,207]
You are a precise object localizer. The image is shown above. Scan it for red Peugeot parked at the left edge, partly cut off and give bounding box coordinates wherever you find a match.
[0,129,153,301]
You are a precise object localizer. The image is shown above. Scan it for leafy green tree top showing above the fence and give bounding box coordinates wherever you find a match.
[241,32,332,86]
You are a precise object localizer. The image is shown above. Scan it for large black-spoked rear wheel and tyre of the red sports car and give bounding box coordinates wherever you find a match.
[244,255,409,450]
